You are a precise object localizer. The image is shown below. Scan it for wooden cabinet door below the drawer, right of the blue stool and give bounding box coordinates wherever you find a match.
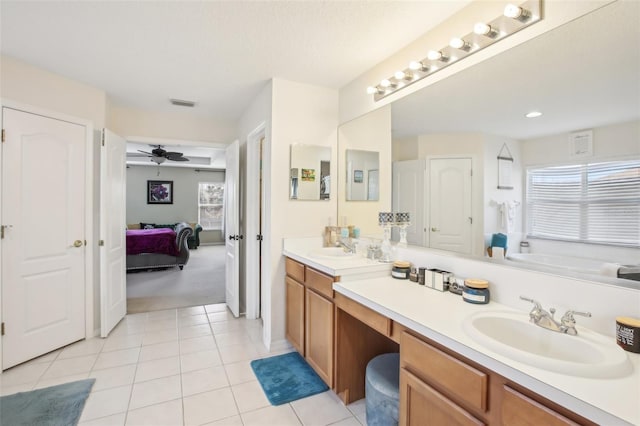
[400,368,485,426]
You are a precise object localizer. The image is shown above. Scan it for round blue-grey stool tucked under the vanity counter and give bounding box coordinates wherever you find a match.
[364,353,400,426]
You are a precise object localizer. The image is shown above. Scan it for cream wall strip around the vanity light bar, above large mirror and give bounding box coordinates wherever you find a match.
[340,0,613,123]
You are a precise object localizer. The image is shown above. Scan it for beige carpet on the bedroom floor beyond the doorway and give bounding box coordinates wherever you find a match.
[127,245,225,314]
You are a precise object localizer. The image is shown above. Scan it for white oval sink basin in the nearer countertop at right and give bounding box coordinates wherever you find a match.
[463,311,633,378]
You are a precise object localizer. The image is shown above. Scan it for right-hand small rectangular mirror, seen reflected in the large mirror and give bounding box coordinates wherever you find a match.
[345,149,380,201]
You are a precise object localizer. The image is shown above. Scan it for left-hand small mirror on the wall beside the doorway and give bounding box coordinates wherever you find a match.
[289,144,331,200]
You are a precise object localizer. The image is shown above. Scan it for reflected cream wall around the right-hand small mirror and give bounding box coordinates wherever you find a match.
[338,106,391,236]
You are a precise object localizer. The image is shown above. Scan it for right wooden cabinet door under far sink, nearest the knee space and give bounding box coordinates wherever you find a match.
[305,289,334,388]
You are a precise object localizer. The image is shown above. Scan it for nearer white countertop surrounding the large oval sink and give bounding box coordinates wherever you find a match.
[334,276,640,425]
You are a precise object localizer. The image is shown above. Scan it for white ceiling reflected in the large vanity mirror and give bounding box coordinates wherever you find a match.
[392,1,640,139]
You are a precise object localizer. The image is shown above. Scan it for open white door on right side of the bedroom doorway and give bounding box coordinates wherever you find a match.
[224,141,243,317]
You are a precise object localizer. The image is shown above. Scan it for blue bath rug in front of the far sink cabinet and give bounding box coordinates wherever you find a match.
[251,352,329,405]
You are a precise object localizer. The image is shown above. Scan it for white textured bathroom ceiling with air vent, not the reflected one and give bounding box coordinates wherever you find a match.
[0,0,470,122]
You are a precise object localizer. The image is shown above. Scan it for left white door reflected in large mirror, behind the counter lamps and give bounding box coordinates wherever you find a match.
[391,159,426,246]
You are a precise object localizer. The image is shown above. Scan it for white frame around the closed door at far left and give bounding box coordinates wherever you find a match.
[0,98,95,373]
